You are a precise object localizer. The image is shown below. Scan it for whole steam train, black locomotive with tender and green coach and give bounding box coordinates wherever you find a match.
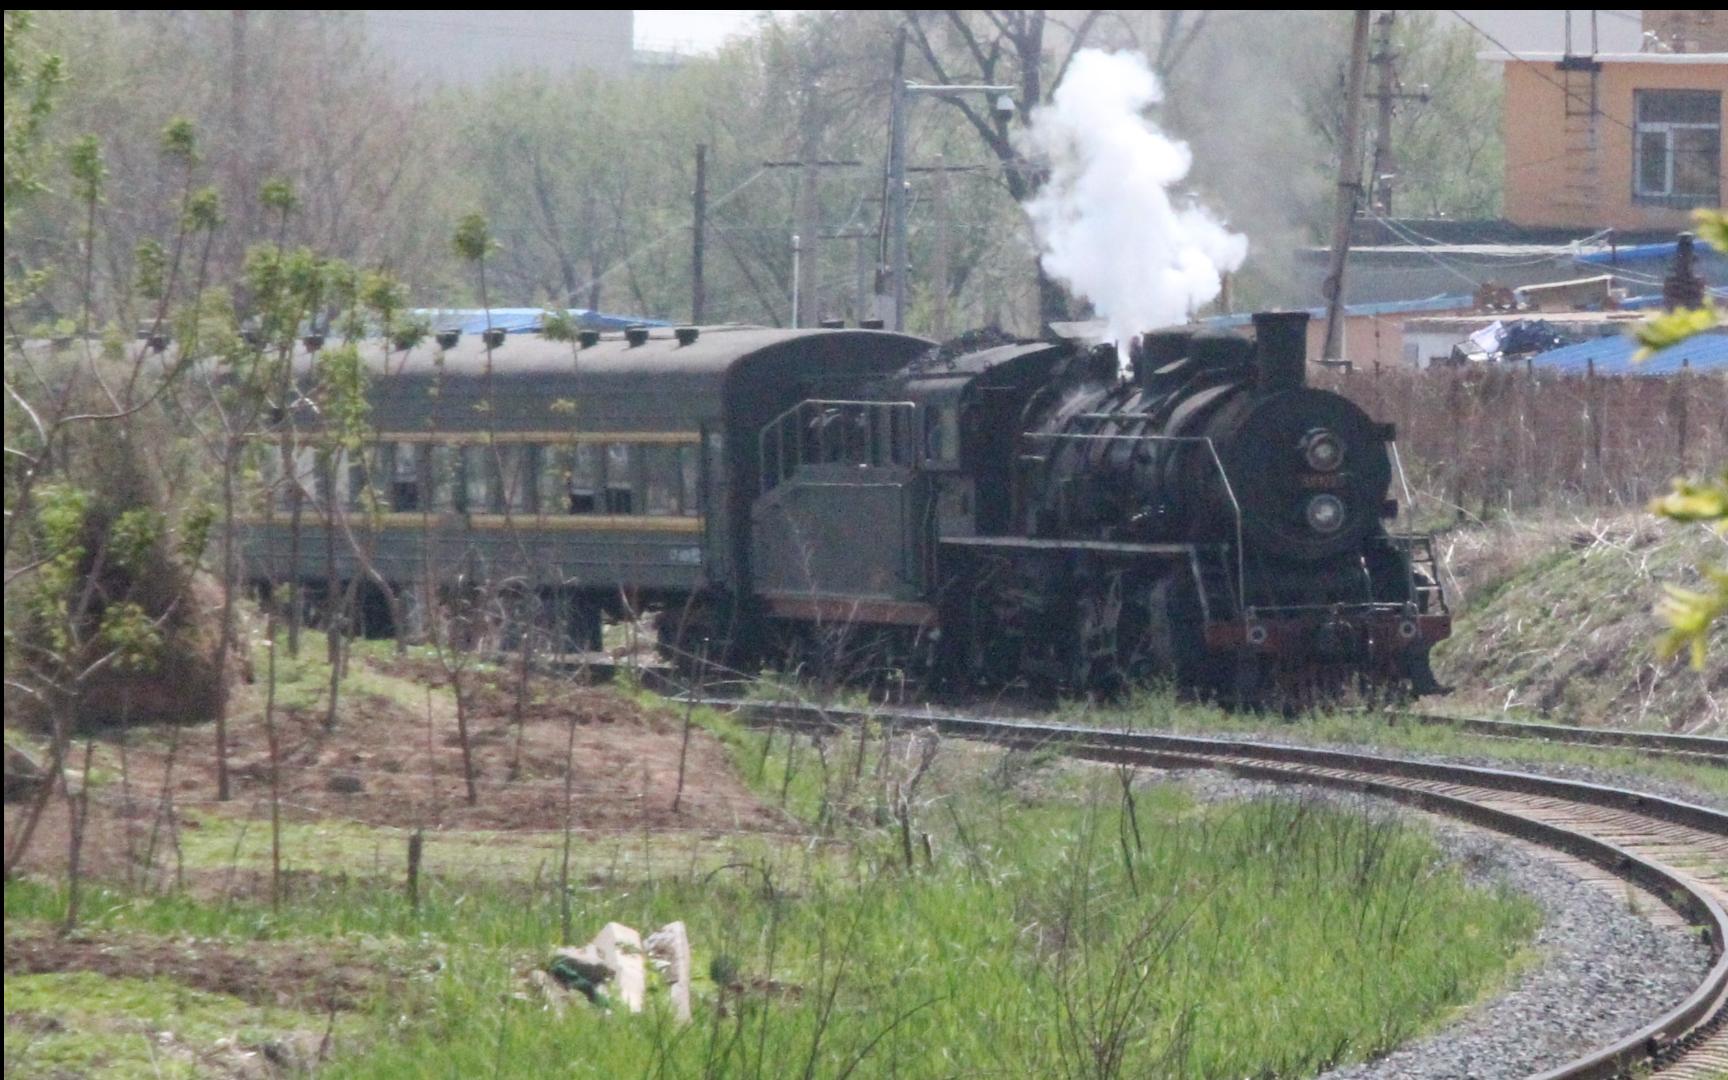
[245,313,1450,702]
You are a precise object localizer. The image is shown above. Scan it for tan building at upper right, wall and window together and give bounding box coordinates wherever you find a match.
[1488,50,1728,232]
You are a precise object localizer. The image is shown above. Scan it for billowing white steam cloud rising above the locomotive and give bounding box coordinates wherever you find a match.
[1020,48,1248,353]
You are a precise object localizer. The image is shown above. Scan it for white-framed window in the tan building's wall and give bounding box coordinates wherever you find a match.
[1631,90,1723,207]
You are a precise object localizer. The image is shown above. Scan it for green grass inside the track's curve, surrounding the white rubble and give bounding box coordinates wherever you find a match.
[5,698,1538,1077]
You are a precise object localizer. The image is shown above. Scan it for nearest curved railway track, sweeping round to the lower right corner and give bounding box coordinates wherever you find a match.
[698,698,1728,1080]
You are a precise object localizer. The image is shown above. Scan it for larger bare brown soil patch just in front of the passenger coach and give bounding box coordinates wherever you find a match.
[5,658,798,891]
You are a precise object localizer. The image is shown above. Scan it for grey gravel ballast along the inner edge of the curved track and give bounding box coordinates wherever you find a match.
[1178,772,1709,1080]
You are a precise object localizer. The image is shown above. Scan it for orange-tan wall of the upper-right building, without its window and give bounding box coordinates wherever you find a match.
[1503,55,1728,232]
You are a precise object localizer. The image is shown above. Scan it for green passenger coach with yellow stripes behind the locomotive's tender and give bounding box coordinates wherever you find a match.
[240,327,931,648]
